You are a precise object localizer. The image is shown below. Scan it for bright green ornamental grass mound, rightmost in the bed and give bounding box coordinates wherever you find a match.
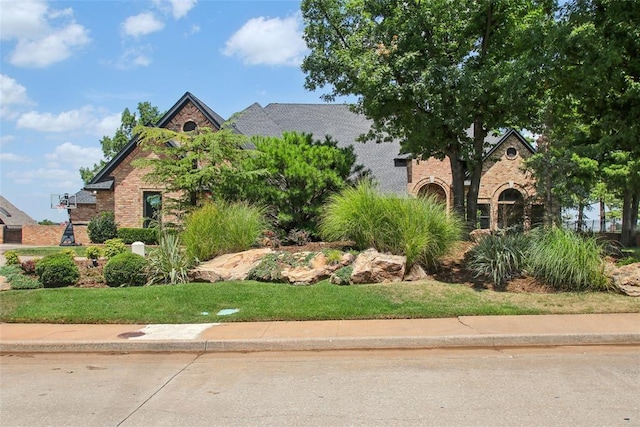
[527,227,609,291]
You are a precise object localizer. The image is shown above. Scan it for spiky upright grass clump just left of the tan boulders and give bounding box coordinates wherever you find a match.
[147,233,191,285]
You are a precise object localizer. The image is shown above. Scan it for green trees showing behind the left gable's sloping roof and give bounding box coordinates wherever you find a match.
[80,102,164,184]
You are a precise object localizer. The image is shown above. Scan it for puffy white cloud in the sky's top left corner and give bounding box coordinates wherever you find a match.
[0,0,91,68]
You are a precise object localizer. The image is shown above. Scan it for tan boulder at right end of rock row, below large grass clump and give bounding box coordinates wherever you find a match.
[351,249,407,284]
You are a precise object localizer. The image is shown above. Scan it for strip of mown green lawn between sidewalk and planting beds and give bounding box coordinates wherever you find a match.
[0,281,640,323]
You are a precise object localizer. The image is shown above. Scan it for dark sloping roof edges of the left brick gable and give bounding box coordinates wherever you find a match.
[84,92,225,190]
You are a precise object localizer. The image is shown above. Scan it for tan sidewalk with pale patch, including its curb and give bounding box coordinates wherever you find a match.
[0,313,640,353]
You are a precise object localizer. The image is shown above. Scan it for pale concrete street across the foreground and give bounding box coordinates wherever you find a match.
[0,346,640,427]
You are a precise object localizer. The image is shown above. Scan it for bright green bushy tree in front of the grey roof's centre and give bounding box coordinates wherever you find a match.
[226,132,366,234]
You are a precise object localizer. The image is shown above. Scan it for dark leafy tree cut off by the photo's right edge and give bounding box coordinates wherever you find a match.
[560,0,640,245]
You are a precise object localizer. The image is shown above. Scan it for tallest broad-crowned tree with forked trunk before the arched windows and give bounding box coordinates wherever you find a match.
[302,0,555,231]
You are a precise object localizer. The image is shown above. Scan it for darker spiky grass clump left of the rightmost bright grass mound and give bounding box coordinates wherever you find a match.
[467,233,529,287]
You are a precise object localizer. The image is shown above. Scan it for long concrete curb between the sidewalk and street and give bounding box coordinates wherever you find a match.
[5,332,640,353]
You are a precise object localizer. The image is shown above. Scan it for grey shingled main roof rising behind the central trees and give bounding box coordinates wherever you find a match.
[232,103,407,194]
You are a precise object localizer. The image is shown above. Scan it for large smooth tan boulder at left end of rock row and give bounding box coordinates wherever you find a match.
[193,248,273,282]
